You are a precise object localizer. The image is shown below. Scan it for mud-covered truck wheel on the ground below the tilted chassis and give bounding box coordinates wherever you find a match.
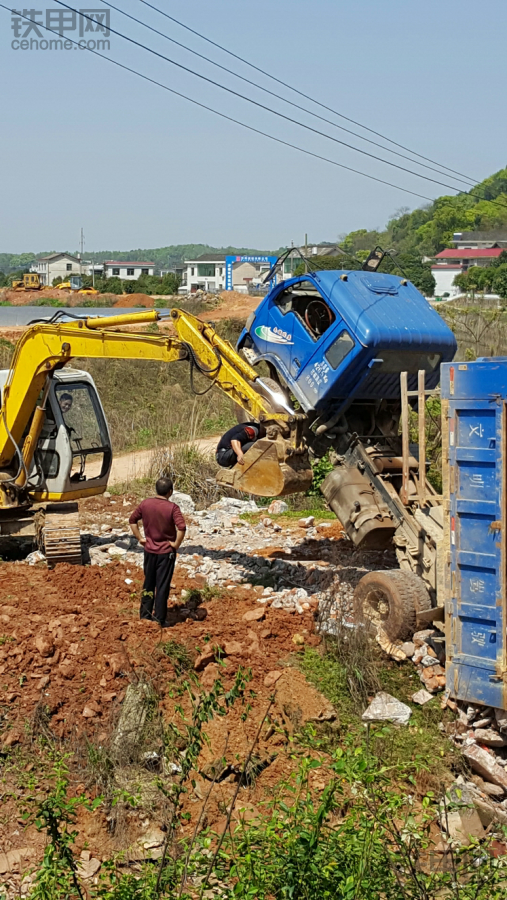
[353,569,431,641]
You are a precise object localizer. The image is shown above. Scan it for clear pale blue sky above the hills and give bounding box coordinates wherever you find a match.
[0,0,507,256]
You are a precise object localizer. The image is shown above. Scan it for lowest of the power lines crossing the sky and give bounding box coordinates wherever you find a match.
[0,3,436,203]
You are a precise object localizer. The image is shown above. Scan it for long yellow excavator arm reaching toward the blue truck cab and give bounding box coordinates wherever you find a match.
[0,309,311,508]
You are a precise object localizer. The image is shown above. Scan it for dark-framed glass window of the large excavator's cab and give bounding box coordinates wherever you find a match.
[56,382,108,454]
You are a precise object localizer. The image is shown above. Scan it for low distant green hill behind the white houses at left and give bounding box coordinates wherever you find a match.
[0,244,272,272]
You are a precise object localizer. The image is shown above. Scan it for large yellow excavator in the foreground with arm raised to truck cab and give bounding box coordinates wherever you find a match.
[0,309,312,565]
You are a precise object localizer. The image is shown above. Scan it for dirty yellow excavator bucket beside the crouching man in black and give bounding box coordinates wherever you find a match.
[216,436,313,497]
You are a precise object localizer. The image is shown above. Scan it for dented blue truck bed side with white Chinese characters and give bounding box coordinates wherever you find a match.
[441,357,507,709]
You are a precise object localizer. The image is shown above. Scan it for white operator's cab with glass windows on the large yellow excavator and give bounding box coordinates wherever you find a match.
[30,368,112,501]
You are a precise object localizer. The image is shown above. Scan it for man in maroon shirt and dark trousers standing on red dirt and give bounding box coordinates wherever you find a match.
[129,478,187,628]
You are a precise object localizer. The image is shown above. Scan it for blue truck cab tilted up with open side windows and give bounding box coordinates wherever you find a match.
[237,270,456,414]
